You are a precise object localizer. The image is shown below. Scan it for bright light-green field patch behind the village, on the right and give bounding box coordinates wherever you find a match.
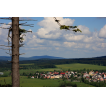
[56,63,106,70]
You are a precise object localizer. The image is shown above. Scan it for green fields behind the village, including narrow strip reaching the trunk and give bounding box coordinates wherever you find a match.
[4,63,106,75]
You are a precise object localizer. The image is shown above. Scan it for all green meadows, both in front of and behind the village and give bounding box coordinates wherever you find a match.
[0,63,106,87]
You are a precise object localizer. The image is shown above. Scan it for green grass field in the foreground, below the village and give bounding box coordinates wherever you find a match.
[0,76,94,87]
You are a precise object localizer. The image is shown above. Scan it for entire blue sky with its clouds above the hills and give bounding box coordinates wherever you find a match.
[0,17,106,58]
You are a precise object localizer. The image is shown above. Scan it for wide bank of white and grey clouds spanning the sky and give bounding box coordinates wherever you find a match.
[0,17,106,58]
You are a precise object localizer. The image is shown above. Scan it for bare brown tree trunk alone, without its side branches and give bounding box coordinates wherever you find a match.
[12,17,20,87]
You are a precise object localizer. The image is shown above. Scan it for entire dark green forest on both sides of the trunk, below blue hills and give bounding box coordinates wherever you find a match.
[0,56,106,71]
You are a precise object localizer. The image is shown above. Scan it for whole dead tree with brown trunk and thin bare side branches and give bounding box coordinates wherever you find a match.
[0,17,37,87]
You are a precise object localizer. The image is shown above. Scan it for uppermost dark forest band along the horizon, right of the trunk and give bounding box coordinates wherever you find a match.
[17,57,106,66]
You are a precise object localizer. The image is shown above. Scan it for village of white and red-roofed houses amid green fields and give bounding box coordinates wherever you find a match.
[31,70,106,82]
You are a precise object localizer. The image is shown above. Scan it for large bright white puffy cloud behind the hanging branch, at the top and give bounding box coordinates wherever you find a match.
[37,17,75,39]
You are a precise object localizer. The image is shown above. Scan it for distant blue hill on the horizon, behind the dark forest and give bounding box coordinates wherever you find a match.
[0,55,65,61]
